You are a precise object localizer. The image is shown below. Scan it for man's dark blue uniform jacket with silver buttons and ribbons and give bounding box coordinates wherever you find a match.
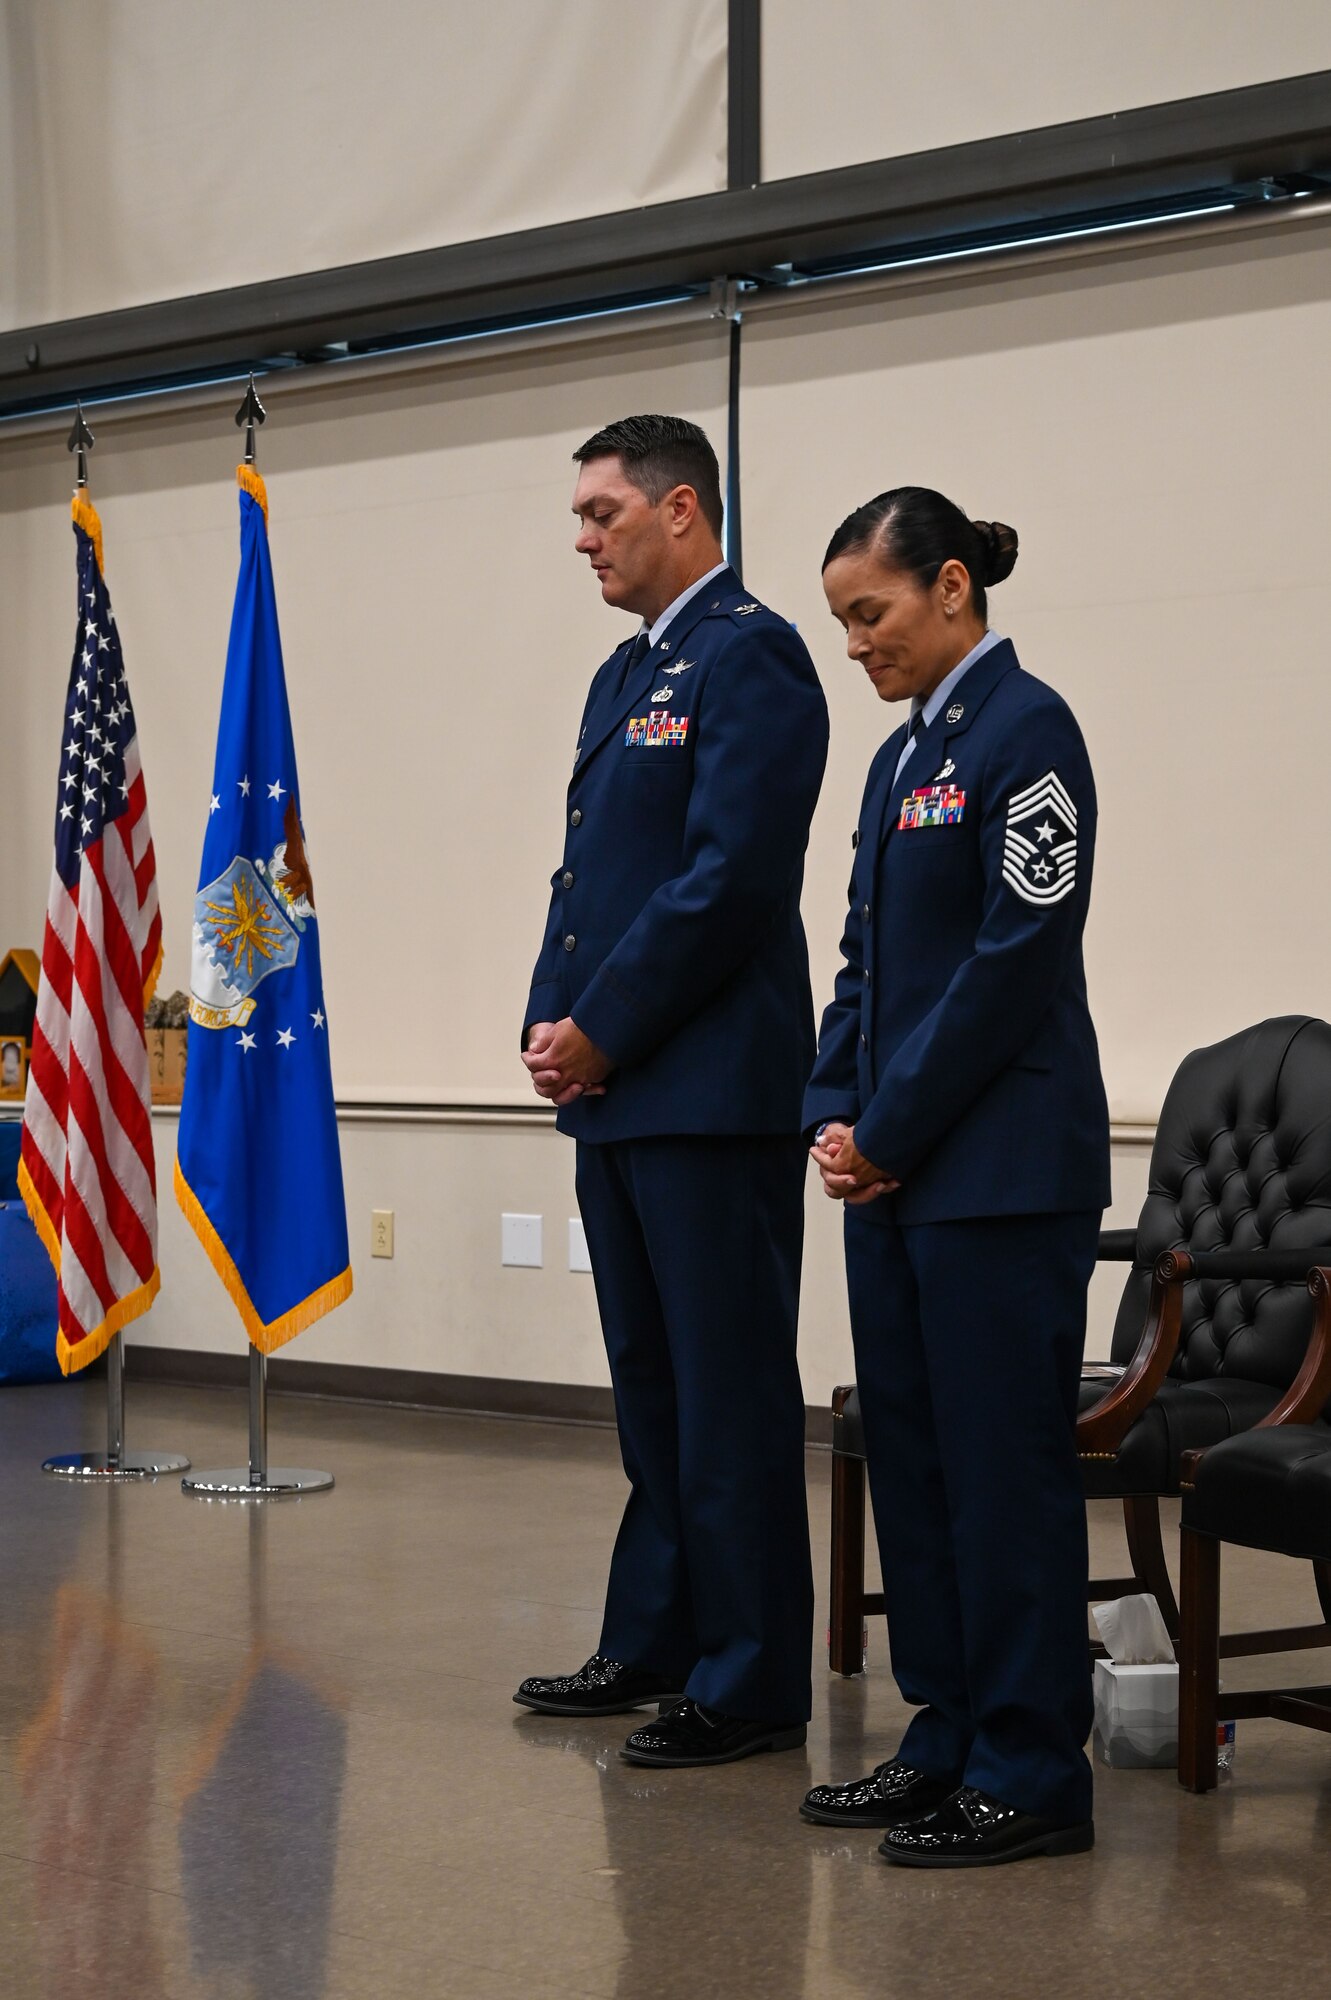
[524,570,827,1140]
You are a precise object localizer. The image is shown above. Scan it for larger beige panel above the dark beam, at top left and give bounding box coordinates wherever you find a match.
[0,0,725,326]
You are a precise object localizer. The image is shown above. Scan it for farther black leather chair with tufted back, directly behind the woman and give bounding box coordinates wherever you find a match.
[827,1014,1331,1674]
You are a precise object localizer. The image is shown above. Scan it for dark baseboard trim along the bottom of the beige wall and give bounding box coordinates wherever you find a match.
[124,1344,831,1448]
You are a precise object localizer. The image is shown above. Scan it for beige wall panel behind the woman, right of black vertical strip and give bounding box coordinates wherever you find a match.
[743,224,1331,1122]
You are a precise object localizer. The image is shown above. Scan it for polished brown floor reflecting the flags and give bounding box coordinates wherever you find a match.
[0,1384,1331,2000]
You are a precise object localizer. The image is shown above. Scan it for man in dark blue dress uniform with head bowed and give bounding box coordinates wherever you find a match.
[516,416,827,1764]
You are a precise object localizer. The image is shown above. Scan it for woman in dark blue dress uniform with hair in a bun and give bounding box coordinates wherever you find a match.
[803,486,1109,1866]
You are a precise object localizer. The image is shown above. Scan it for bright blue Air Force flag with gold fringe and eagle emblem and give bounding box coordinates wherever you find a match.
[176,466,352,1354]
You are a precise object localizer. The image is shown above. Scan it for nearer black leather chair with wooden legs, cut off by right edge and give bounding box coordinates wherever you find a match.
[1179,1268,1331,1792]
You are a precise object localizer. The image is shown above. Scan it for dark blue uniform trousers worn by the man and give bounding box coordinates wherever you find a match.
[578,1136,813,1722]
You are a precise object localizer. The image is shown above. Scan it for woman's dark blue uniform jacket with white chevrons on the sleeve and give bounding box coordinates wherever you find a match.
[803,640,1109,1224]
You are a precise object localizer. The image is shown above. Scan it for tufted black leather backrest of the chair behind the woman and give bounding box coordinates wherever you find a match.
[1113,1014,1331,1388]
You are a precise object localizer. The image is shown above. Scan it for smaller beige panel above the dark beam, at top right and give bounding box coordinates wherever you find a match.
[763,0,1331,180]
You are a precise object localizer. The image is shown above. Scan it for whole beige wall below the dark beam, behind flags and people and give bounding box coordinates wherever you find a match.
[0,207,1331,1402]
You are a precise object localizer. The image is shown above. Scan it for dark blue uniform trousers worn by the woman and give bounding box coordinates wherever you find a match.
[845,1202,1101,1826]
